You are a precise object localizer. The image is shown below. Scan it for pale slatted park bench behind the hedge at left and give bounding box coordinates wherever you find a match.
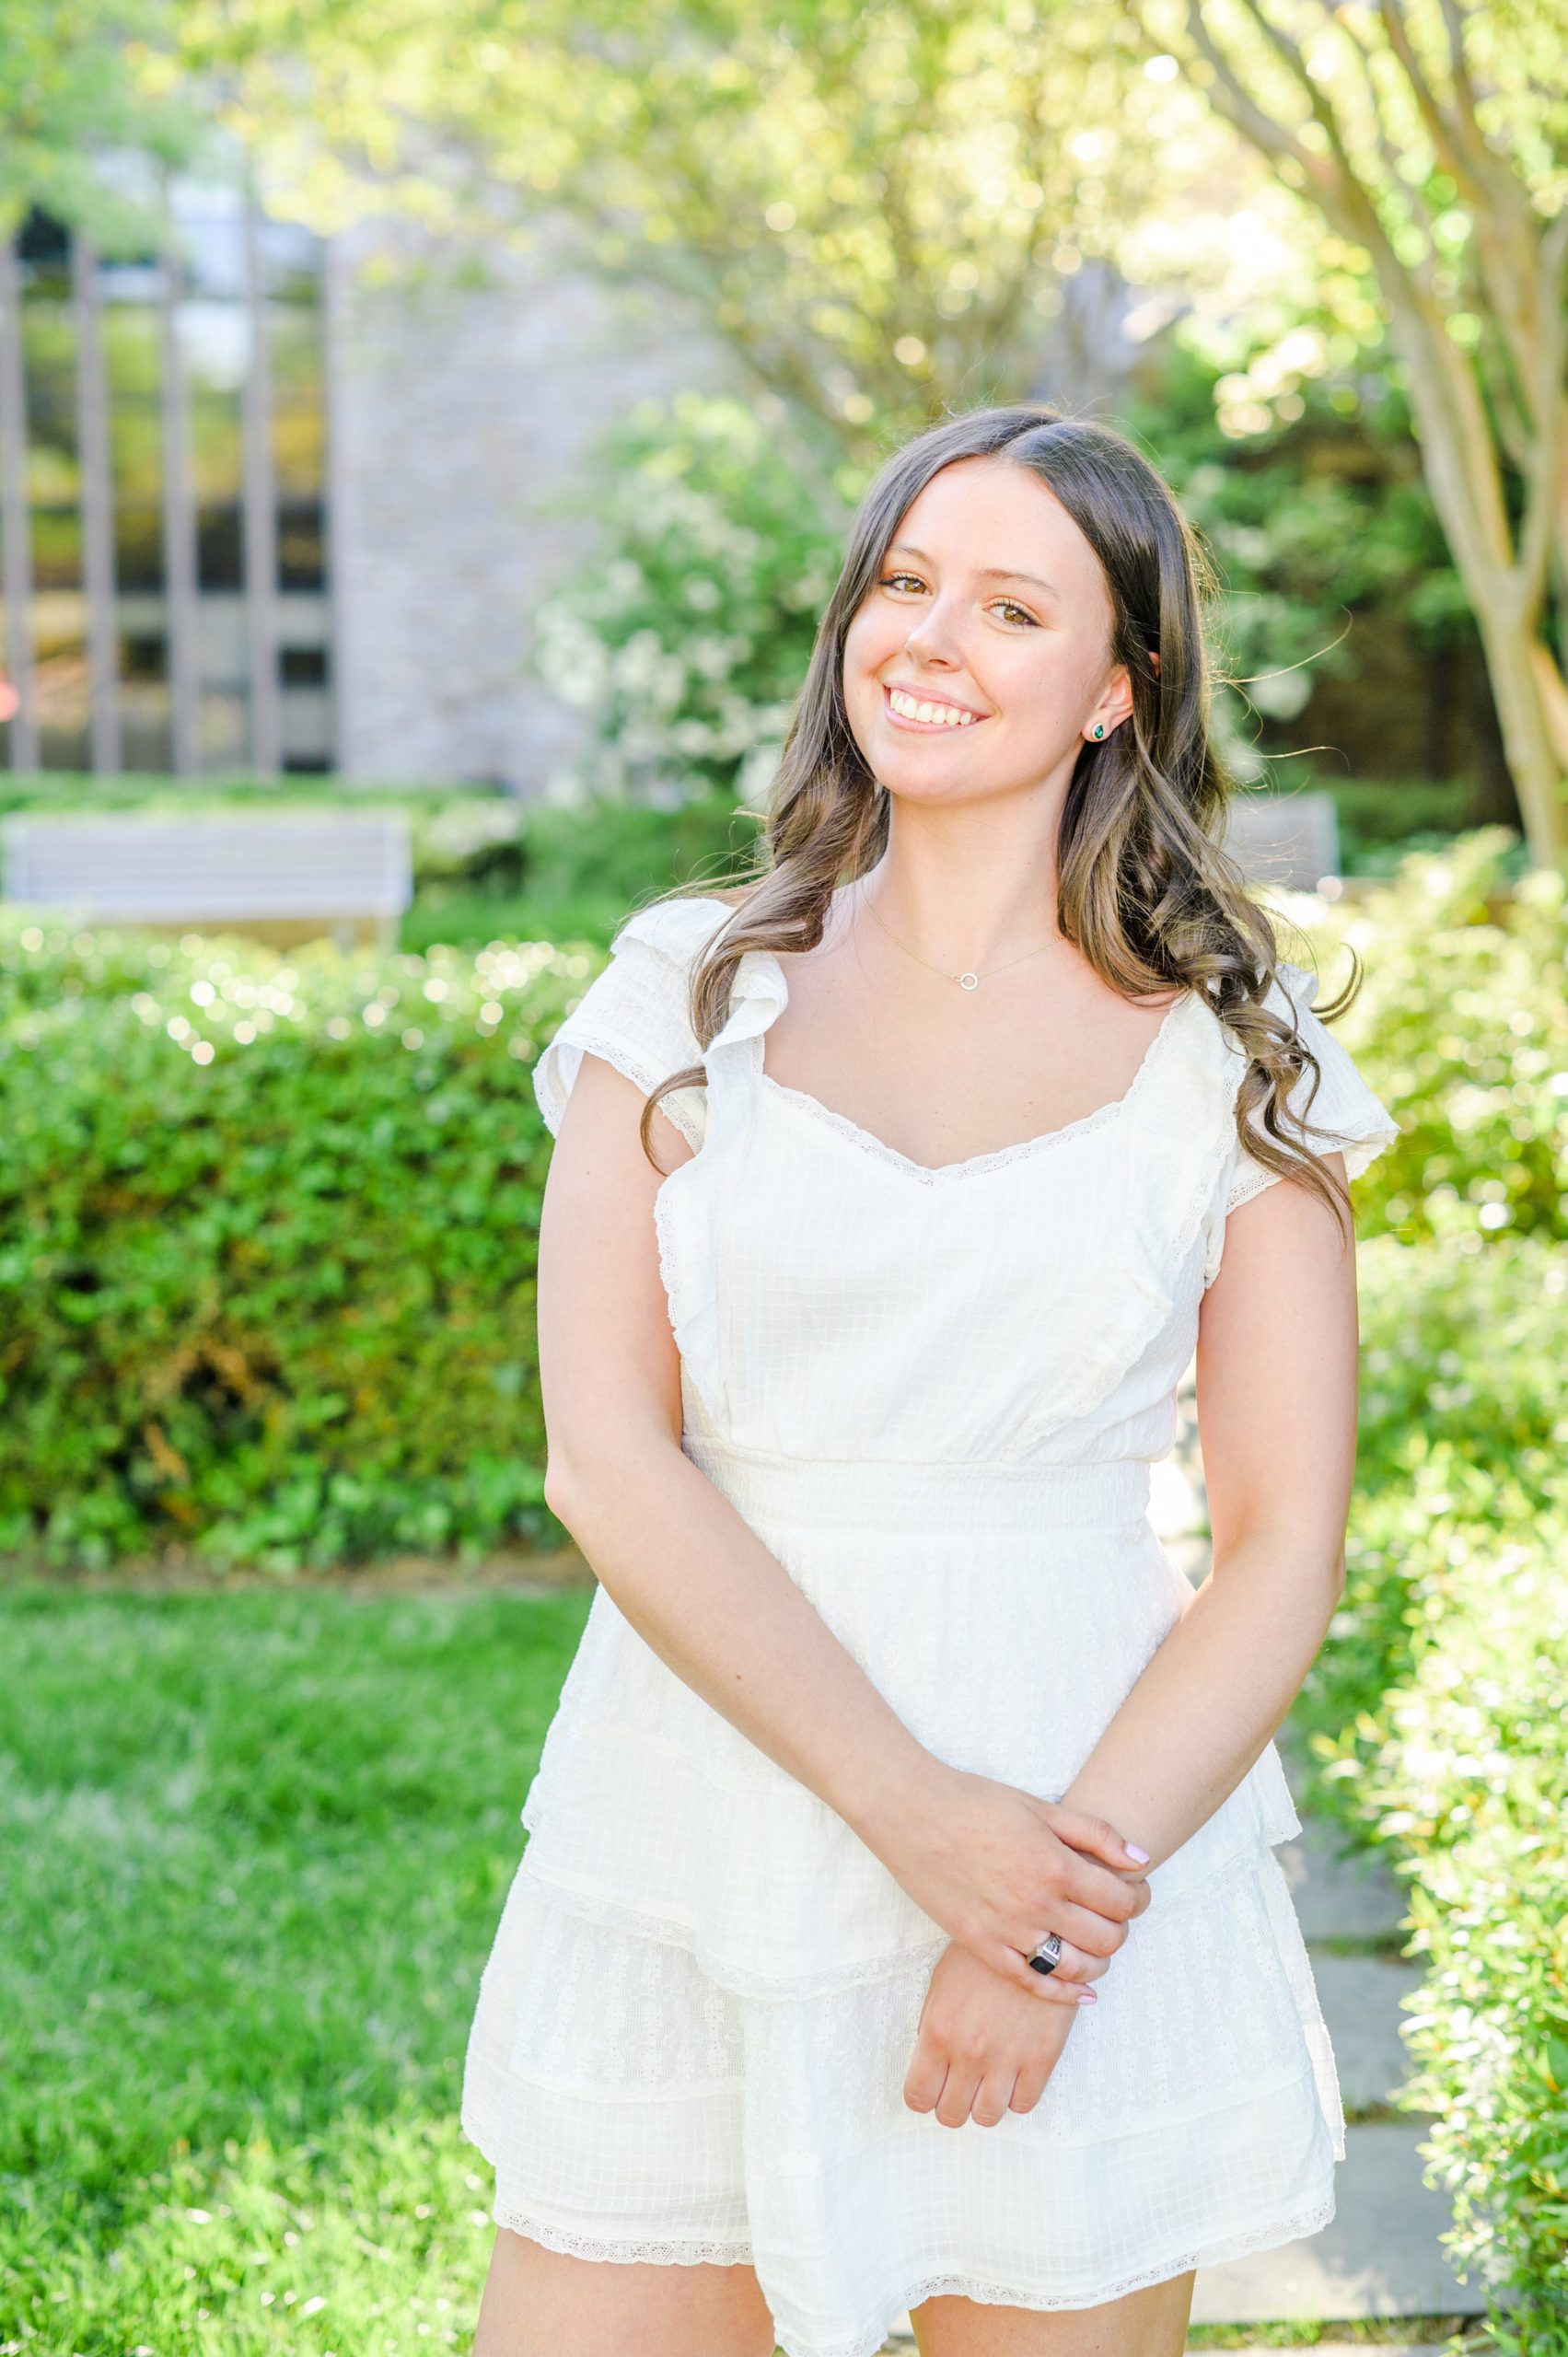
[0,811,412,947]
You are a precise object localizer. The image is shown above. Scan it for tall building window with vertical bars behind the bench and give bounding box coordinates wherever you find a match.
[0,181,332,775]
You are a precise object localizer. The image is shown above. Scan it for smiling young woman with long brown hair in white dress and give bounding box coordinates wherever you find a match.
[462,408,1393,2357]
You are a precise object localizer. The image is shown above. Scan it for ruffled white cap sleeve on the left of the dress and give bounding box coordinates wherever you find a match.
[533,900,733,1150]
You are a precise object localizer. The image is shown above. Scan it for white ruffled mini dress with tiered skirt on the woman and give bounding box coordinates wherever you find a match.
[462,898,1396,2357]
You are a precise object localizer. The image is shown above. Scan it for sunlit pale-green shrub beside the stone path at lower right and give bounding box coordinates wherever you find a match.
[1356,1514,1568,2357]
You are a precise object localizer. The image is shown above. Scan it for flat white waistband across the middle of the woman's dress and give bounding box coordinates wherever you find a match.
[681,1433,1148,1535]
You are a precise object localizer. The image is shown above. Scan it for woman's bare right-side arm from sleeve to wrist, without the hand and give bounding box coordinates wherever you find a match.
[1037,1155,1358,1864]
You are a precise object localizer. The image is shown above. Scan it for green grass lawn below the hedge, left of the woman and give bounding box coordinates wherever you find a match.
[0,1586,587,2357]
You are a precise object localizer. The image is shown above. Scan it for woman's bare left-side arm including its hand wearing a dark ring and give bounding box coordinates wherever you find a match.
[538,1053,1148,1994]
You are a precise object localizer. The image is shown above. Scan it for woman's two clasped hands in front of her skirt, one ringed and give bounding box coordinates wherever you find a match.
[875,1768,1151,2129]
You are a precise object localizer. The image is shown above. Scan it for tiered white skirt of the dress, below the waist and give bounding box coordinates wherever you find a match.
[462,1447,1344,2357]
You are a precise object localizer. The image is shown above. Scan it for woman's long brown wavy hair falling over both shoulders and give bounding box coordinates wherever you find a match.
[642,403,1361,1233]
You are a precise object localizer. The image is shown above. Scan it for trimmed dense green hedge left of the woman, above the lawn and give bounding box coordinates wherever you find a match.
[0,914,597,1570]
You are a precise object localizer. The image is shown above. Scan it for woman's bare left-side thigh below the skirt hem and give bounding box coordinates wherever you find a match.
[474,2225,773,2357]
